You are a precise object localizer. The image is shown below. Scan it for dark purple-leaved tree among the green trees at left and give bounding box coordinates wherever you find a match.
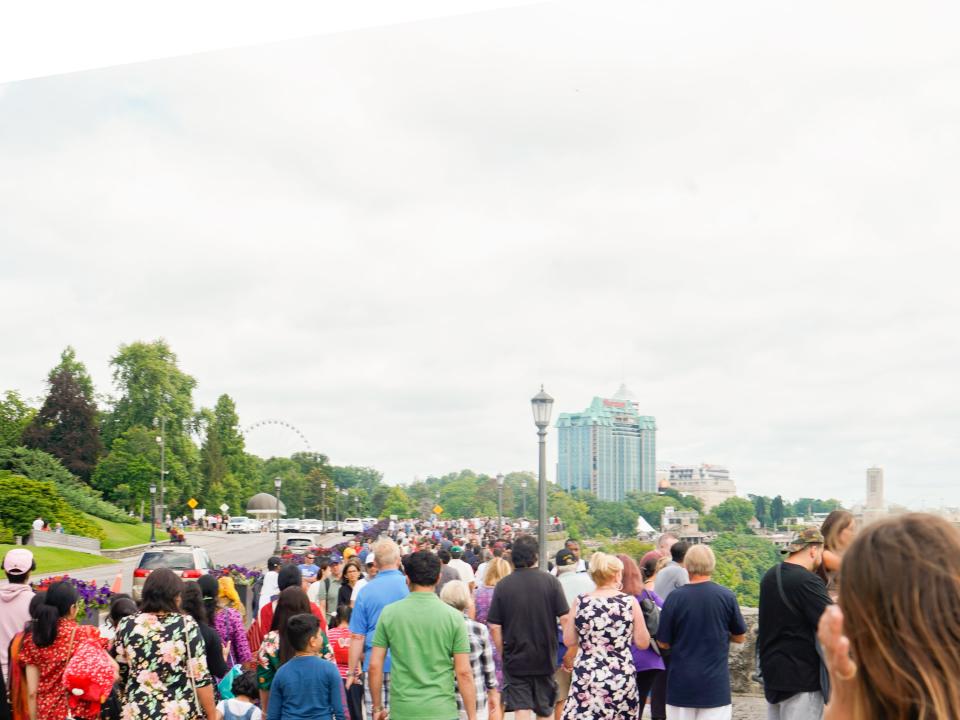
[23,347,103,481]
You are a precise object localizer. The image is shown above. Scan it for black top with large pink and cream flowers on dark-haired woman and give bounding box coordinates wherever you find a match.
[113,613,213,720]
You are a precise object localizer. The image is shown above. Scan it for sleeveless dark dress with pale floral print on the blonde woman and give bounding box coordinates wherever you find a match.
[563,594,641,720]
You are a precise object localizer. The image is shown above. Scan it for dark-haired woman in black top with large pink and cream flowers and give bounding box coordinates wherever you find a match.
[113,568,217,720]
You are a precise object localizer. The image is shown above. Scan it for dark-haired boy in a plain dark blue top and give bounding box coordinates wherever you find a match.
[267,613,346,720]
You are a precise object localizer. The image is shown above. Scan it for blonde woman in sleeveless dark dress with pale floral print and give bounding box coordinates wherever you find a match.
[563,552,650,720]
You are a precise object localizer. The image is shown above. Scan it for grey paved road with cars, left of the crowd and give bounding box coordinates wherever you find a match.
[32,531,349,592]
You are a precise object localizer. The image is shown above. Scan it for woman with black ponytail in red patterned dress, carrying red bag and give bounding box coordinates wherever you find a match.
[20,582,109,720]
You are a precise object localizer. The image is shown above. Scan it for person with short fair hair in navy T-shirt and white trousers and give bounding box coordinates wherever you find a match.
[657,545,747,720]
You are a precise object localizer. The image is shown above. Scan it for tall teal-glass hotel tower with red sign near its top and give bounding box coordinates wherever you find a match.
[557,385,657,500]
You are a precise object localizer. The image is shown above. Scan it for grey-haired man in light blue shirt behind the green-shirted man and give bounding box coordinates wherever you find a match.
[346,538,410,718]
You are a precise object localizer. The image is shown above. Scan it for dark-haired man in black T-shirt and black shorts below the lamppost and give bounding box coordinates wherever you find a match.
[487,535,570,720]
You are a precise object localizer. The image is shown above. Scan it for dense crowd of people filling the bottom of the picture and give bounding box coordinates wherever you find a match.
[0,511,960,720]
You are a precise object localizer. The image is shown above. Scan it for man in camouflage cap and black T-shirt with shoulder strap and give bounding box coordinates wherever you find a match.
[757,528,831,720]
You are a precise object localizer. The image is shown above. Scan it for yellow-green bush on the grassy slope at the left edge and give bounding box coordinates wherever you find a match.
[0,470,106,540]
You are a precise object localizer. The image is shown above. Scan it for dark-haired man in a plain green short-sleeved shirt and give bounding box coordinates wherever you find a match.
[368,550,477,720]
